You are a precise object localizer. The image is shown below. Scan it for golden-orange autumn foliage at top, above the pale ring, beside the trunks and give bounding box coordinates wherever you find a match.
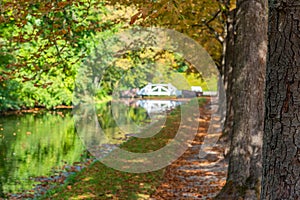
[107,0,224,66]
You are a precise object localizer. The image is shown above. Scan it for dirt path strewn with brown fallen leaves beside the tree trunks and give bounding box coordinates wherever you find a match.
[151,102,227,200]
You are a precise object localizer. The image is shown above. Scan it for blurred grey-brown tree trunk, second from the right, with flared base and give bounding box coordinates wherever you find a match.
[216,0,267,199]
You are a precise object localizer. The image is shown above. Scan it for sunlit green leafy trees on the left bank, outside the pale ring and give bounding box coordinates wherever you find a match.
[0,0,121,111]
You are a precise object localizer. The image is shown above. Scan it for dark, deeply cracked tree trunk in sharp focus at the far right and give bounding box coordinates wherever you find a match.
[261,0,300,200]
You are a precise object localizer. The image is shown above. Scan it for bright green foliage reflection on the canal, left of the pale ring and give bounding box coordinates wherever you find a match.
[0,112,85,196]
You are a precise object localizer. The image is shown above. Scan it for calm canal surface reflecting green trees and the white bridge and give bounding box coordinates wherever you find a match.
[0,100,180,197]
